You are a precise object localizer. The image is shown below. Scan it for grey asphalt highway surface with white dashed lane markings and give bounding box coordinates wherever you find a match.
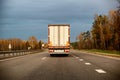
[0,50,120,80]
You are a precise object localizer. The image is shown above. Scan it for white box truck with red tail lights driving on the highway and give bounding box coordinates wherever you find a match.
[48,24,70,56]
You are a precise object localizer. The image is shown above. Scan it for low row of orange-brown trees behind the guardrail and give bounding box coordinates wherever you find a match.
[0,36,43,51]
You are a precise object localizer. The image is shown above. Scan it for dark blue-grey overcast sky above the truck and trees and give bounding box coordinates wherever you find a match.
[0,0,118,42]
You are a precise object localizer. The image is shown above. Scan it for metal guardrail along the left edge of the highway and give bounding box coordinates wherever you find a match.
[0,50,42,59]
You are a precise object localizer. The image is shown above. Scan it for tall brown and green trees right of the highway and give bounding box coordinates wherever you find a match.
[77,9,120,50]
